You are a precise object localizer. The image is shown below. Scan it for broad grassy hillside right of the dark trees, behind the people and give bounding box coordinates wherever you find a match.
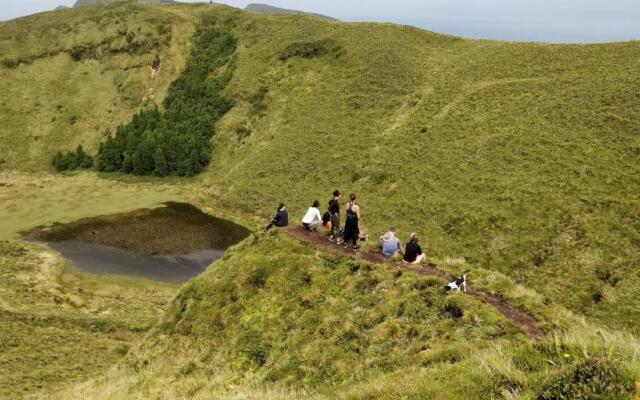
[202,13,640,331]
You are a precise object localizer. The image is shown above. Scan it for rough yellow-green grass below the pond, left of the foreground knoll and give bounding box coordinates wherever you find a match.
[0,241,177,398]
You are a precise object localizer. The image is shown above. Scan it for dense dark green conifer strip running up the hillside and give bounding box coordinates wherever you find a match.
[97,21,236,176]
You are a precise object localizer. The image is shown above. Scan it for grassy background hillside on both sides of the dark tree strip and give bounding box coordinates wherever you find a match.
[0,0,640,331]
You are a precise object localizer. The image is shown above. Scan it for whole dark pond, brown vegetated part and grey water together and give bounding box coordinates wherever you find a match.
[28,203,250,284]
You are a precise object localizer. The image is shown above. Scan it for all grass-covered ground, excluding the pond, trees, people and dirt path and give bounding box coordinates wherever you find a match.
[0,3,640,399]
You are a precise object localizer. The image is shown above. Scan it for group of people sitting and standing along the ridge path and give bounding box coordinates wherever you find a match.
[264,190,425,264]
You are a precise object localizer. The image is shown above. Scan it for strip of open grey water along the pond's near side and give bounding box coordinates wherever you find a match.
[49,241,225,284]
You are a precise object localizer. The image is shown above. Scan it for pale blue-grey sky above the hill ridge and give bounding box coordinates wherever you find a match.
[0,0,640,43]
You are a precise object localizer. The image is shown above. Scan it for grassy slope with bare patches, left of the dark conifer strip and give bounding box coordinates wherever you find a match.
[0,3,201,171]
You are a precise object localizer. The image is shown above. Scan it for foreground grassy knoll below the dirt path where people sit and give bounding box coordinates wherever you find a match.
[48,233,640,399]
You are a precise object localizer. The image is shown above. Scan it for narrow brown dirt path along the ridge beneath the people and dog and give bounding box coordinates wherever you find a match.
[283,225,544,340]
